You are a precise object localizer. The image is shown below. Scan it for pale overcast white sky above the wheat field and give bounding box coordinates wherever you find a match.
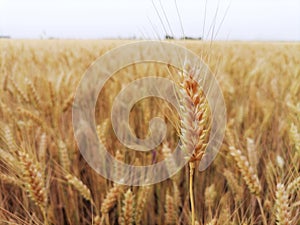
[0,0,300,41]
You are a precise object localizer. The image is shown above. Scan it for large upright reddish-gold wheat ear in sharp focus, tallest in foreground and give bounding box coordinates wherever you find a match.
[178,64,208,162]
